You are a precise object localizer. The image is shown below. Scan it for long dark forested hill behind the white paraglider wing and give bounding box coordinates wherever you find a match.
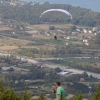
[0,2,100,26]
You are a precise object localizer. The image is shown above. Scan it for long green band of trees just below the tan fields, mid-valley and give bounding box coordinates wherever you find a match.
[18,47,81,57]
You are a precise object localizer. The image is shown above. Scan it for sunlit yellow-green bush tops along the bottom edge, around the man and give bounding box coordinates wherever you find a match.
[0,83,100,100]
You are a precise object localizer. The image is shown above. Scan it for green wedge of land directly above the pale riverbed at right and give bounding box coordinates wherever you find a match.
[49,55,100,73]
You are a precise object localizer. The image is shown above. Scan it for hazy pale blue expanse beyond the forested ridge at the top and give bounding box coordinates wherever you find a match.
[22,0,100,12]
